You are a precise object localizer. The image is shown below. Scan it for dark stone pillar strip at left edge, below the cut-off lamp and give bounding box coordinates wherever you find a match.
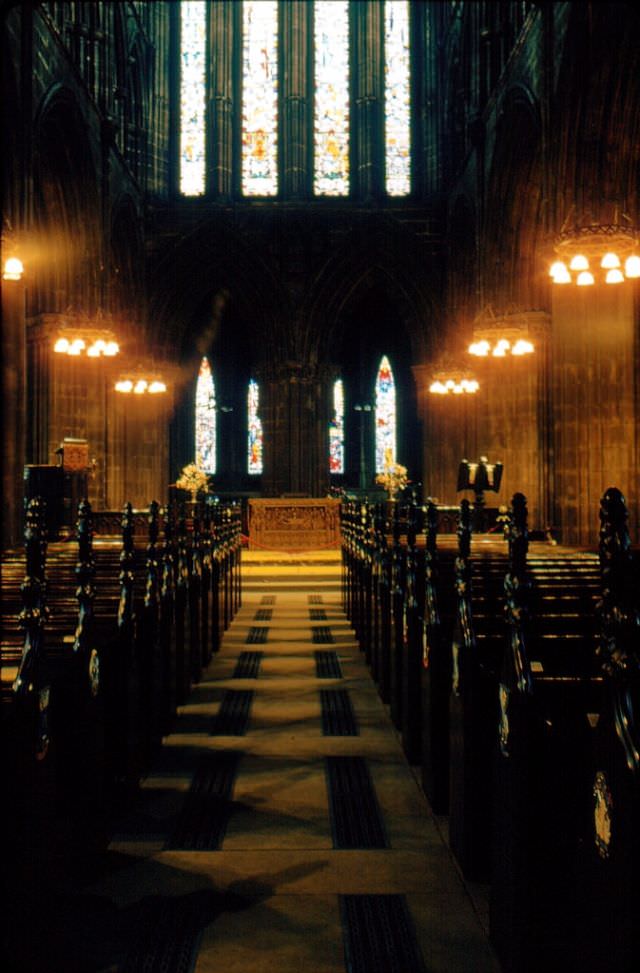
[1,280,27,549]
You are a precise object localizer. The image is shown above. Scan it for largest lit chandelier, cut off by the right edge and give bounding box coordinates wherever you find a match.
[549,223,640,287]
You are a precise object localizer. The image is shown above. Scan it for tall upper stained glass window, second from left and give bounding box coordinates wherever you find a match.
[242,0,278,196]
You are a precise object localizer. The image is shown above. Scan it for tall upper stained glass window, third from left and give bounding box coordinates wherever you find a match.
[313,0,349,196]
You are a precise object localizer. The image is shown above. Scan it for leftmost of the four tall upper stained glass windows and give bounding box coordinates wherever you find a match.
[180,0,207,196]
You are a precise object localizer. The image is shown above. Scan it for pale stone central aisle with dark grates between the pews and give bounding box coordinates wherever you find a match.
[101,554,498,973]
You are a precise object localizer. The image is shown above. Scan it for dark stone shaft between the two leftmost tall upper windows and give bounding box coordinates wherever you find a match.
[208,3,234,198]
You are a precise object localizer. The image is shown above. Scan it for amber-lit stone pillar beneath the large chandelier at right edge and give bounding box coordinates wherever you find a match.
[551,281,640,545]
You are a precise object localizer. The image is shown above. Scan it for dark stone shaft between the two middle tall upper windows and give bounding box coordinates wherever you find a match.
[280,0,312,199]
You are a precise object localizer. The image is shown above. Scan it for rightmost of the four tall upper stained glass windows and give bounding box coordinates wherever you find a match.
[384,0,411,196]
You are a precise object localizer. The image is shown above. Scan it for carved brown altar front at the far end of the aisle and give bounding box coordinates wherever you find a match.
[249,497,340,551]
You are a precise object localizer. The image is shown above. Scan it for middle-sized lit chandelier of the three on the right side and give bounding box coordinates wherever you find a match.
[468,305,546,358]
